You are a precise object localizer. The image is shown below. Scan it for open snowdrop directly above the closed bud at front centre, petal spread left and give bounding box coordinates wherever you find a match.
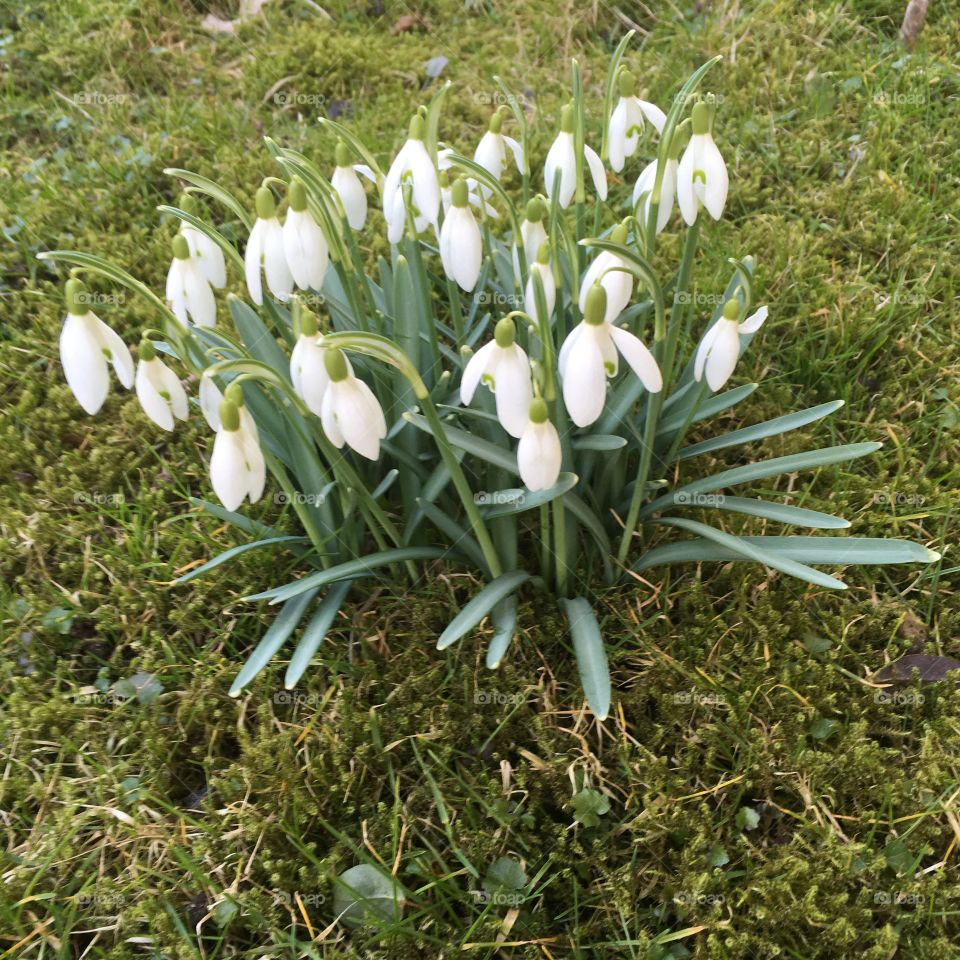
[460,317,533,437]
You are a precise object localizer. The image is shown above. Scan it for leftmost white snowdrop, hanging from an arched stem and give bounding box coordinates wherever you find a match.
[60,278,133,414]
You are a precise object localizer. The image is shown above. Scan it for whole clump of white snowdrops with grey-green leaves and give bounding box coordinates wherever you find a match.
[41,36,936,718]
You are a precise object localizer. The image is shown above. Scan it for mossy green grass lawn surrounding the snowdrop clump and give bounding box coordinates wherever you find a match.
[0,0,960,960]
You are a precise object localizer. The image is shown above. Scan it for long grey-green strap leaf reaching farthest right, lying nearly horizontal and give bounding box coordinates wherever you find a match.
[633,536,940,570]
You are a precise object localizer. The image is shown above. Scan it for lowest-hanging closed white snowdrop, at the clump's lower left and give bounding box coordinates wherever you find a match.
[210,386,267,510]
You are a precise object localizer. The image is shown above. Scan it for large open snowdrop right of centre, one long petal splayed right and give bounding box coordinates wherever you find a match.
[557,283,663,427]
